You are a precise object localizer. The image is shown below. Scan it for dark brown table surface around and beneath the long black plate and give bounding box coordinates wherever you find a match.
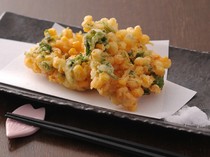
[0,0,210,157]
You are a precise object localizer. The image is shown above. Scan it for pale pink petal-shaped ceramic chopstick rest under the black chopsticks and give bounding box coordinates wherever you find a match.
[6,104,45,139]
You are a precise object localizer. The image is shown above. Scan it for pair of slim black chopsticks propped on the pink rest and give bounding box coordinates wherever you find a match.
[5,112,184,157]
